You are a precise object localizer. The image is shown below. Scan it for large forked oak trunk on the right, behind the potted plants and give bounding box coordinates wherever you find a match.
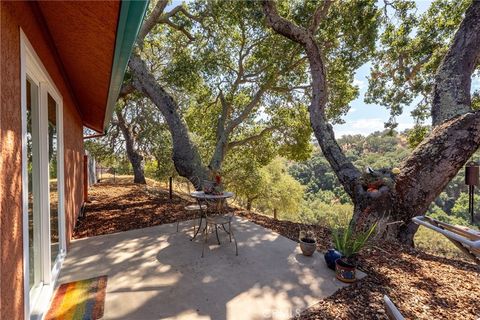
[263,0,480,245]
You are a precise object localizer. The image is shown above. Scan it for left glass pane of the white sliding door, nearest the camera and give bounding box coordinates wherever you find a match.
[26,79,42,292]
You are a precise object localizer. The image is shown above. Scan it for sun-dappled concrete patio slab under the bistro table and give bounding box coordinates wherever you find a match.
[59,218,364,320]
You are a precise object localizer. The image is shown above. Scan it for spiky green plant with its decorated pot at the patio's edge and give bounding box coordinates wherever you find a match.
[333,223,377,283]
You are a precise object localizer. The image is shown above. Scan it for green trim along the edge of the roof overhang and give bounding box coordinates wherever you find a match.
[103,0,149,132]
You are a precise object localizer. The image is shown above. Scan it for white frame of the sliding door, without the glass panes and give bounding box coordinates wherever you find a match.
[20,29,66,319]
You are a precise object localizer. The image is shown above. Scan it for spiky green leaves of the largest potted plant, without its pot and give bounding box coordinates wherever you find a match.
[333,223,377,263]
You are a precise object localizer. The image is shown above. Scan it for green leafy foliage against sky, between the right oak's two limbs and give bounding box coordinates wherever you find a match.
[365,0,471,131]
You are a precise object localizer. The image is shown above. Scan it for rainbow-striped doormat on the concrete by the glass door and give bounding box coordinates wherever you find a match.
[45,276,107,320]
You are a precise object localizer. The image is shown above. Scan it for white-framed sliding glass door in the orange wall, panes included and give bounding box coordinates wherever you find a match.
[22,31,65,317]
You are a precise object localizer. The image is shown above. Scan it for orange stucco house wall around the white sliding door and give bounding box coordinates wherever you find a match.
[0,1,83,320]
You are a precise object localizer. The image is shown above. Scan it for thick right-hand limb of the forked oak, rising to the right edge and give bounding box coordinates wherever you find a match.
[396,1,480,222]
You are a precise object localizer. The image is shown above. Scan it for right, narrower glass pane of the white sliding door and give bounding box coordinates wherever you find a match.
[48,94,60,267]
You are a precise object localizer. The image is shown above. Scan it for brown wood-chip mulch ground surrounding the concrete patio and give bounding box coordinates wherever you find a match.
[74,183,480,320]
